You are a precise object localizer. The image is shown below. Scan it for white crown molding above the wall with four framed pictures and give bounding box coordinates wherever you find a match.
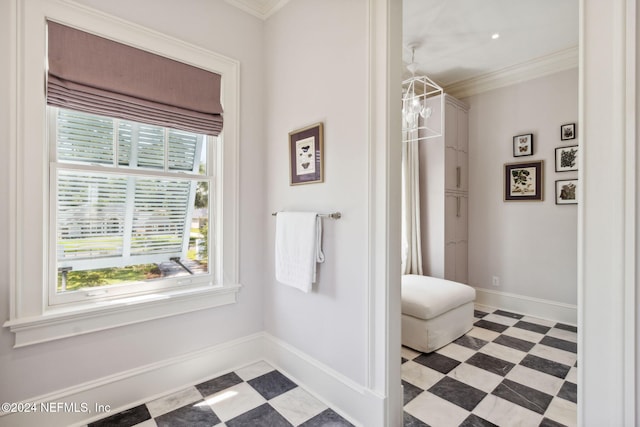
[444,46,579,98]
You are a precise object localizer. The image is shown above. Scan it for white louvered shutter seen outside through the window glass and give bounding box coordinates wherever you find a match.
[56,109,203,270]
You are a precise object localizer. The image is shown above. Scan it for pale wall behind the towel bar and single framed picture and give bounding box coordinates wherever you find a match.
[260,0,369,384]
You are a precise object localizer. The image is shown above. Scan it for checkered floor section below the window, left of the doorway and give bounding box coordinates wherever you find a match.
[89,362,353,427]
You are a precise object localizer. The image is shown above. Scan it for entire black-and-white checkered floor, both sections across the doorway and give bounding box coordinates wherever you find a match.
[84,308,577,427]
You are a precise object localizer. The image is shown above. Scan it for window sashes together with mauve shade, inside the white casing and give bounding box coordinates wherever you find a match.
[47,22,222,305]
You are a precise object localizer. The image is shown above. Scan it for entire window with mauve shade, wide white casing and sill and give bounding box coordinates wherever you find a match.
[4,2,240,347]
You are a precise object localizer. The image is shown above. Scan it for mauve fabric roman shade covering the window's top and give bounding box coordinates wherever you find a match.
[47,21,222,136]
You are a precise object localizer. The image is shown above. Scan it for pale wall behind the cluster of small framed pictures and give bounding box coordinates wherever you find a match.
[464,69,580,305]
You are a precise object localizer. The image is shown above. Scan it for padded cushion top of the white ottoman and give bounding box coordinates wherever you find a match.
[402,274,476,320]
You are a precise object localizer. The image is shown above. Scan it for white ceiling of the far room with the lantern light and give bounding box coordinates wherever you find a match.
[403,0,578,87]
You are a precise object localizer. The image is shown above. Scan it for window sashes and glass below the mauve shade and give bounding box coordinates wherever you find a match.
[48,107,213,305]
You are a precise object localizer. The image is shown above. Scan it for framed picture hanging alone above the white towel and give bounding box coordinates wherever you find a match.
[289,123,324,185]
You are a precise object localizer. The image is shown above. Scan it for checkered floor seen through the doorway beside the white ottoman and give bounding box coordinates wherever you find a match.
[402,310,577,427]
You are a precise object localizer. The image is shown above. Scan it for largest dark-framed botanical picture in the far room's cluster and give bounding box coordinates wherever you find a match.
[504,160,544,201]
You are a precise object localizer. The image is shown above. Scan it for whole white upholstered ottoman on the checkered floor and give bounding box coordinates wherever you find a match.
[402,274,476,353]
